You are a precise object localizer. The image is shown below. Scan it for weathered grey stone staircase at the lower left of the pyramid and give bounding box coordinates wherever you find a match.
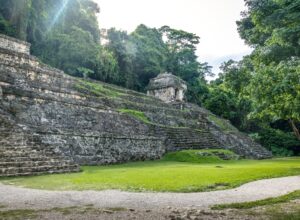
[0,133,79,177]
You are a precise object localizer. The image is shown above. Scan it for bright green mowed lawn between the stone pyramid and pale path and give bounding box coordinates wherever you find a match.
[0,150,300,192]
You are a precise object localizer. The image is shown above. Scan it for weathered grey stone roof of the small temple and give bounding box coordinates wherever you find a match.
[147,73,186,90]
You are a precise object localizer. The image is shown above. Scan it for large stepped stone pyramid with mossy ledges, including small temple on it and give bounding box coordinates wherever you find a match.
[0,35,272,176]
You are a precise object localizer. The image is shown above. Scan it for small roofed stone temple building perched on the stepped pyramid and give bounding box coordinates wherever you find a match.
[147,73,187,102]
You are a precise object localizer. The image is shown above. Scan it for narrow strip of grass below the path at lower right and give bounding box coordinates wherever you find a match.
[212,191,300,210]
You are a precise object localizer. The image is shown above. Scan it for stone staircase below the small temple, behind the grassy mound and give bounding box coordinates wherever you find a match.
[155,127,221,151]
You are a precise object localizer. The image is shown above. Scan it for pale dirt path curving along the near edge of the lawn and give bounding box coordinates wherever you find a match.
[0,176,300,209]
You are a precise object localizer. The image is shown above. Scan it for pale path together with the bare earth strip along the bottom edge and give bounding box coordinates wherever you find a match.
[0,176,300,220]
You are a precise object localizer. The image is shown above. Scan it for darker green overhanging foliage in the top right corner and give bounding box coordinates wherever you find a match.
[237,0,300,62]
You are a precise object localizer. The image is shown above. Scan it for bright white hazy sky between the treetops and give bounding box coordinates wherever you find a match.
[95,0,251,73]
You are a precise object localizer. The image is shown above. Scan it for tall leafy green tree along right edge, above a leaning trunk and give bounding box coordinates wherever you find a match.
[237,0,300,140]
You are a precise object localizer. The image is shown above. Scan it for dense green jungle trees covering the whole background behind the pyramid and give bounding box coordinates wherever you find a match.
[0,0,300,156]
